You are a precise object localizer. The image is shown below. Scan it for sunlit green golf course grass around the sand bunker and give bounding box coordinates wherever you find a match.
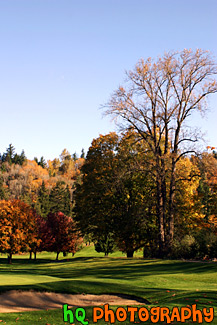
[0,246,217,325]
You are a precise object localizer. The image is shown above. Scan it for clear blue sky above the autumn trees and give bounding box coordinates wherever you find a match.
[0,0,217,160]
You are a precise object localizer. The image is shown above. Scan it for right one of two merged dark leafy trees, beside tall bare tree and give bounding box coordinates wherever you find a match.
[113,132,156,257]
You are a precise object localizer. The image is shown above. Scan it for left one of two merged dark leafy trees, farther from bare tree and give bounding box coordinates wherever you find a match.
[73,133,118,253]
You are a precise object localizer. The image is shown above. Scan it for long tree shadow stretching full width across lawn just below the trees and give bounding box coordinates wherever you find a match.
[0,257,217,280]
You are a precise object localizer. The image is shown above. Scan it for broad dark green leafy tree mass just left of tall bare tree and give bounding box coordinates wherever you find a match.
[74,133,155,257]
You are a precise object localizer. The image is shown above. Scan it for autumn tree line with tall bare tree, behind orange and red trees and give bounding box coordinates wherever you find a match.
[0,50,217,258]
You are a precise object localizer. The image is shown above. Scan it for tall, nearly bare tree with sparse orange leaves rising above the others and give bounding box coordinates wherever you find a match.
[106,49,217,255]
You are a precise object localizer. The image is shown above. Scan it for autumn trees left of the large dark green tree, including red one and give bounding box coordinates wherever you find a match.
[0,144,84,263]
